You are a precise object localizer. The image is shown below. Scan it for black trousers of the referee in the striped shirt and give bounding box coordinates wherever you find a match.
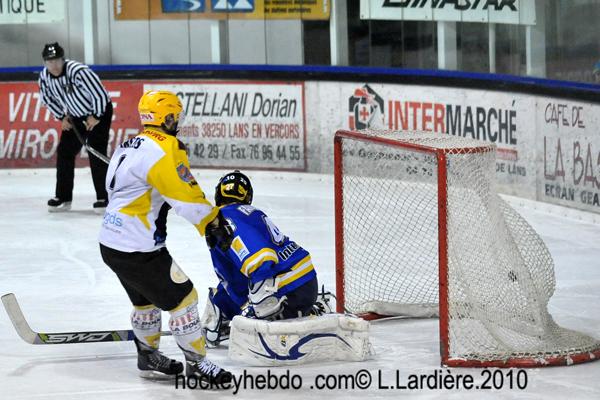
[56,102,113,201]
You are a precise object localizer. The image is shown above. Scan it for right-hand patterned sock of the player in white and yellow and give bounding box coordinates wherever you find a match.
[169,289,206,357]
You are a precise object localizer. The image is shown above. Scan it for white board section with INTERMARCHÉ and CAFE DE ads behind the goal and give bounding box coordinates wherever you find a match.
[305,82,600,213]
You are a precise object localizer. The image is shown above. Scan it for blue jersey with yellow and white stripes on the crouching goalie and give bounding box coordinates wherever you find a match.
[210,204,317,306]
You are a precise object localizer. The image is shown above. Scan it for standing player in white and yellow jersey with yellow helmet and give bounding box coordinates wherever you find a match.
[99,91,232,385]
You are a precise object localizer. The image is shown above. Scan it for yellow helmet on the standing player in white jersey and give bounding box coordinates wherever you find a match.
[138,90,183,127]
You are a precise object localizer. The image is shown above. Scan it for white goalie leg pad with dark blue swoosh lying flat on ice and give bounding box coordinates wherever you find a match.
[229,314,372,366]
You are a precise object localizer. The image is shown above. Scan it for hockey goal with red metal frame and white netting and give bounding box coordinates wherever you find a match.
[334,131,600,367]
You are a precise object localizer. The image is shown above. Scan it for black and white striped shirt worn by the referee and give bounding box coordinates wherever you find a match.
[38,60,110,119]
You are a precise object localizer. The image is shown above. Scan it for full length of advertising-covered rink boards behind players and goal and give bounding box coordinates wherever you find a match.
[0,80,600,213]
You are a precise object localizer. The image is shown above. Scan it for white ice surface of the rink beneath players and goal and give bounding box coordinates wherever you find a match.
[0,169,600,400]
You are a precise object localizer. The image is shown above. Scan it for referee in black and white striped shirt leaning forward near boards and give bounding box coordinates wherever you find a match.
[38,43,113,213]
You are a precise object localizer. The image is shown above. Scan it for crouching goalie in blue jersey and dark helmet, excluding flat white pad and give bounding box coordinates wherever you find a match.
[202,170,319,346]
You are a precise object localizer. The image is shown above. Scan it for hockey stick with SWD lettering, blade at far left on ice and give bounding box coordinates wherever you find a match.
[2,293,171,344]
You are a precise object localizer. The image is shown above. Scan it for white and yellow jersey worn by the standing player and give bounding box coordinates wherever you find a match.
[99,128,219,252]
